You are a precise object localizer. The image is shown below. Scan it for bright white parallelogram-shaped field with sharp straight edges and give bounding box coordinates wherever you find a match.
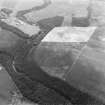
[42,27,96,43]
